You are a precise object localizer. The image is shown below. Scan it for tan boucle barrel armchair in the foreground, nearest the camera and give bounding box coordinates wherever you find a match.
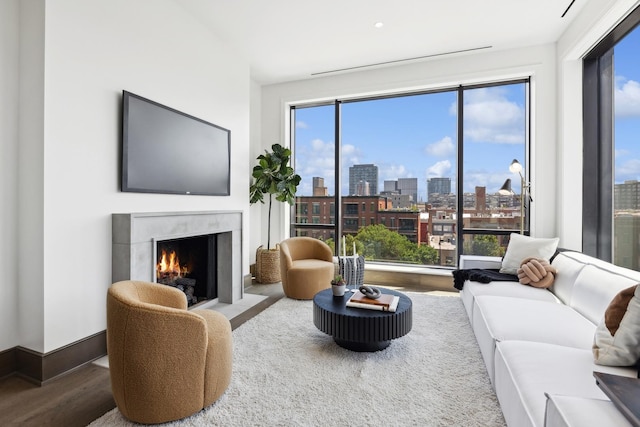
[107,281,232,424]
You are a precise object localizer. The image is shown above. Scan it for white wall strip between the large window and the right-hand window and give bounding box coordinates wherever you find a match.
[557,0,640,250]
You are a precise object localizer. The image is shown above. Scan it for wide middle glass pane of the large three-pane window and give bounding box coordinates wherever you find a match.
[341,91,457,265]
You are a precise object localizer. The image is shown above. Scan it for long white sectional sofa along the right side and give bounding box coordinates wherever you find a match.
[460,251,640,427]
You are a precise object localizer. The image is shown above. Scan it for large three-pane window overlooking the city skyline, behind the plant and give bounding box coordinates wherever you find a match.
[292,80,529,266]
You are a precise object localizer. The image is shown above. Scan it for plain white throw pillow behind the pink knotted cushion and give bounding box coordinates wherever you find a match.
[500,233,560,274]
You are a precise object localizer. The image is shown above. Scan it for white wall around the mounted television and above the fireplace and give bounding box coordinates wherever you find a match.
[10,0,250,352]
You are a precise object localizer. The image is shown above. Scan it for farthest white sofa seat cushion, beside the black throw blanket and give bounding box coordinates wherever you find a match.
[460,281,558,321]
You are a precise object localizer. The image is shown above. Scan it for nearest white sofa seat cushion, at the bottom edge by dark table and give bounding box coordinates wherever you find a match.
[544,393,631,427]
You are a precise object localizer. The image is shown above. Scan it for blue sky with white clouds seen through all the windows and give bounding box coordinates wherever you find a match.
[295,30,640,201]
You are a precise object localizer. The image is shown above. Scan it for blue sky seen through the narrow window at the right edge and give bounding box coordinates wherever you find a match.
[613,28,640,184]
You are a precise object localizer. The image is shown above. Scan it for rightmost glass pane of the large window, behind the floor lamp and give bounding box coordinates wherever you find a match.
[463,83,528,234]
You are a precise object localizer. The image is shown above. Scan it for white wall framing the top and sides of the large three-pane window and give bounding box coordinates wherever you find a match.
[258,45,557,254]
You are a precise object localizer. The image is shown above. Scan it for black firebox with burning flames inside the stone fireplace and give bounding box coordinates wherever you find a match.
[156,234,218,306]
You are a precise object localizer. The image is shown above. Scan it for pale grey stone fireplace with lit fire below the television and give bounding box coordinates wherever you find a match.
[112,211,244,308]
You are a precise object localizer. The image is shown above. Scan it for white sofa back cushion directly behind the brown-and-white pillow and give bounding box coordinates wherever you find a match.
[569,265,640,325]
